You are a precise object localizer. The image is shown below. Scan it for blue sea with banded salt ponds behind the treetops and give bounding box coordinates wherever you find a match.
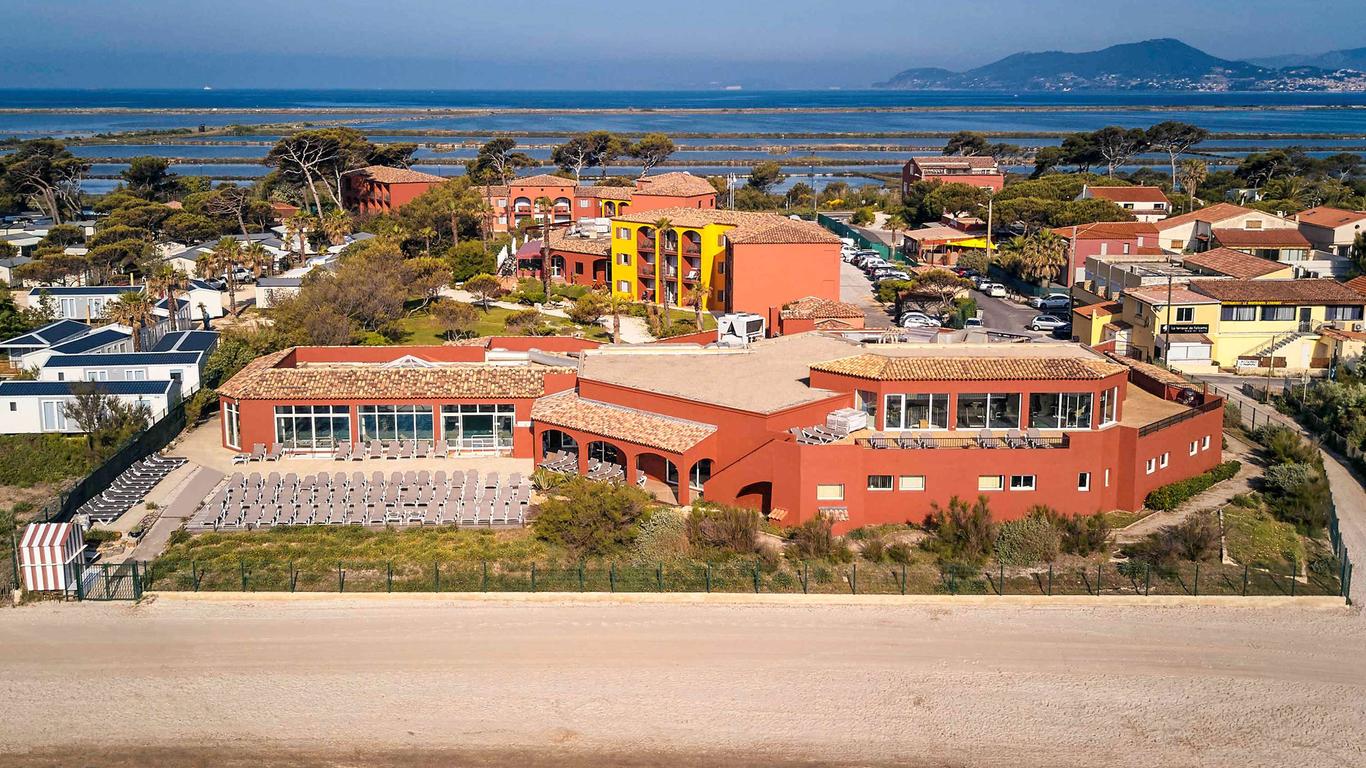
[0,89,1366,191]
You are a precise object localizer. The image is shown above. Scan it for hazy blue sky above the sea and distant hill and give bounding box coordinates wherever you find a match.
[0,0,1366,89]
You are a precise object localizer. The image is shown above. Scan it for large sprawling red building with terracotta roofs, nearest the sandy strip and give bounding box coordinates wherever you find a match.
[219,332,1223,532]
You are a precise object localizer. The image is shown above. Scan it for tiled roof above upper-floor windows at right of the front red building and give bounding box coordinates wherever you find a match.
[811,354,1124,381]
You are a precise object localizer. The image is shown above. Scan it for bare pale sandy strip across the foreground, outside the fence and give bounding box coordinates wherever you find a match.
[0,599,1366,768]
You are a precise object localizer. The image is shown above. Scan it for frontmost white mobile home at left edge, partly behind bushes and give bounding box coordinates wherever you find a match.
[0,380,180,435]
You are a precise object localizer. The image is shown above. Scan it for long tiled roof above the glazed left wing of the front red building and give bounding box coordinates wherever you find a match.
[219,350,574,400]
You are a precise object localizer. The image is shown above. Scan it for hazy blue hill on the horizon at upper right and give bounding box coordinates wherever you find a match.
[873,38,1366,90]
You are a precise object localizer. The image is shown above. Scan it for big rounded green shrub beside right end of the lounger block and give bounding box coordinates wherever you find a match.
[533,477,654,558]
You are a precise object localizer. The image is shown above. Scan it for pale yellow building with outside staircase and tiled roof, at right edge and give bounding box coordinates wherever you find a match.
[1115,279,1366,369]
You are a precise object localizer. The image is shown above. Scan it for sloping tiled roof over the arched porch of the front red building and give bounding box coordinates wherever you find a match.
[531,392,716,454]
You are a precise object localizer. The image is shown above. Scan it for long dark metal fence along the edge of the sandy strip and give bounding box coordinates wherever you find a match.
[133,560,1344,599]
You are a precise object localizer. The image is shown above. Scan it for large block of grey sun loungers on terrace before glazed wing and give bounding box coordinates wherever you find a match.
[187,470,531,530]
